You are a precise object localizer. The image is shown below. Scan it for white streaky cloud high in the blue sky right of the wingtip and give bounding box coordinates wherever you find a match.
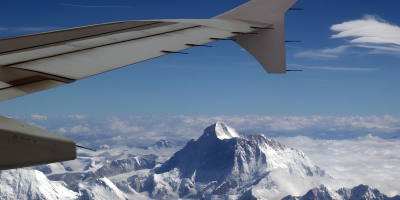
[294,15,400,59]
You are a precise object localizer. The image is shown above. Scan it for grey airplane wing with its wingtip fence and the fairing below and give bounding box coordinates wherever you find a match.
[0,0,296,169]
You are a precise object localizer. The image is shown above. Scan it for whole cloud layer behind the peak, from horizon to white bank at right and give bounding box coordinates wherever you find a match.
[10,115,400,196]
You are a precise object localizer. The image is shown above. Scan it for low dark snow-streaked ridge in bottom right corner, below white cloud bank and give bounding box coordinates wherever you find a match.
[282,185,400,200]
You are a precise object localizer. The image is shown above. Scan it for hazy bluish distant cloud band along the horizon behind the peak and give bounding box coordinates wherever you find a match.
[14,115,400,146]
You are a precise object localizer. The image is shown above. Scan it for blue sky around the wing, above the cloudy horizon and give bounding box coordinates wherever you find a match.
[0,0,400,117]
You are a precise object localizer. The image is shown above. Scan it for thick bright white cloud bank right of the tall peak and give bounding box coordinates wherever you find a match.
[276,135,400,196]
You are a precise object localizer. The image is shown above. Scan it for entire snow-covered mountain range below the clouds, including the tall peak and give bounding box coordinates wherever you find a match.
[0,123,400,200]
